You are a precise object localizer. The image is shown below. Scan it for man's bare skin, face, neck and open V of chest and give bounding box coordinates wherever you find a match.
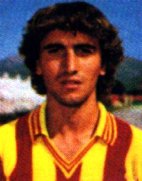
[36,30,105,161]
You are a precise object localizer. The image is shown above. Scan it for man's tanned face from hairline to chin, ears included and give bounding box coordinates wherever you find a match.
[37,30,105,107]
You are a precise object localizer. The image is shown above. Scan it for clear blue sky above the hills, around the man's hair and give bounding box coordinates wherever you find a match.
[0,0,142,61]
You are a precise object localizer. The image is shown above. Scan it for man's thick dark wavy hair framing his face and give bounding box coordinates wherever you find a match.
[19,1,123,101]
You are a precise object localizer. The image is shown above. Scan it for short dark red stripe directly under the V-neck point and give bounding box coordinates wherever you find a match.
[56,164,82,181]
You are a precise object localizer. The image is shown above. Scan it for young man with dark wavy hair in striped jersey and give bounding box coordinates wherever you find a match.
[0,2,142,181]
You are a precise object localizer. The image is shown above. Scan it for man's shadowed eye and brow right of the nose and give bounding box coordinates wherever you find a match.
[75,44,96,56]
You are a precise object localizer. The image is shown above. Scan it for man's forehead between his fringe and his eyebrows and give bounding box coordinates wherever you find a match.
[41,29,98,45]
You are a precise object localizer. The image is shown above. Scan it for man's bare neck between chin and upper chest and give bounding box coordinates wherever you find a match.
[46,94,99,138]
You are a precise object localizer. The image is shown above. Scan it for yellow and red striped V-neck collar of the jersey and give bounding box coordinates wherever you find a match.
[30,102,117,172]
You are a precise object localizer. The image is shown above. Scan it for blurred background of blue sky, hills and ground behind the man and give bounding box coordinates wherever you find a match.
[0,0,142,128]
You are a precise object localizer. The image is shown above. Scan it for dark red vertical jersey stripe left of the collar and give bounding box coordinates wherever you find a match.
[10,115,32,181]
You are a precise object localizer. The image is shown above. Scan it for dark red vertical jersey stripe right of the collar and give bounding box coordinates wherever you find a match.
[104,118,132,181]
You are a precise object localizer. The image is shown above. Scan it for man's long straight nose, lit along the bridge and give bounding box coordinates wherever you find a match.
[64,50,79,74]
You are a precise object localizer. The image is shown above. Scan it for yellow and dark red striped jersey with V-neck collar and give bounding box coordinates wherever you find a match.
[0,103,142,181]
